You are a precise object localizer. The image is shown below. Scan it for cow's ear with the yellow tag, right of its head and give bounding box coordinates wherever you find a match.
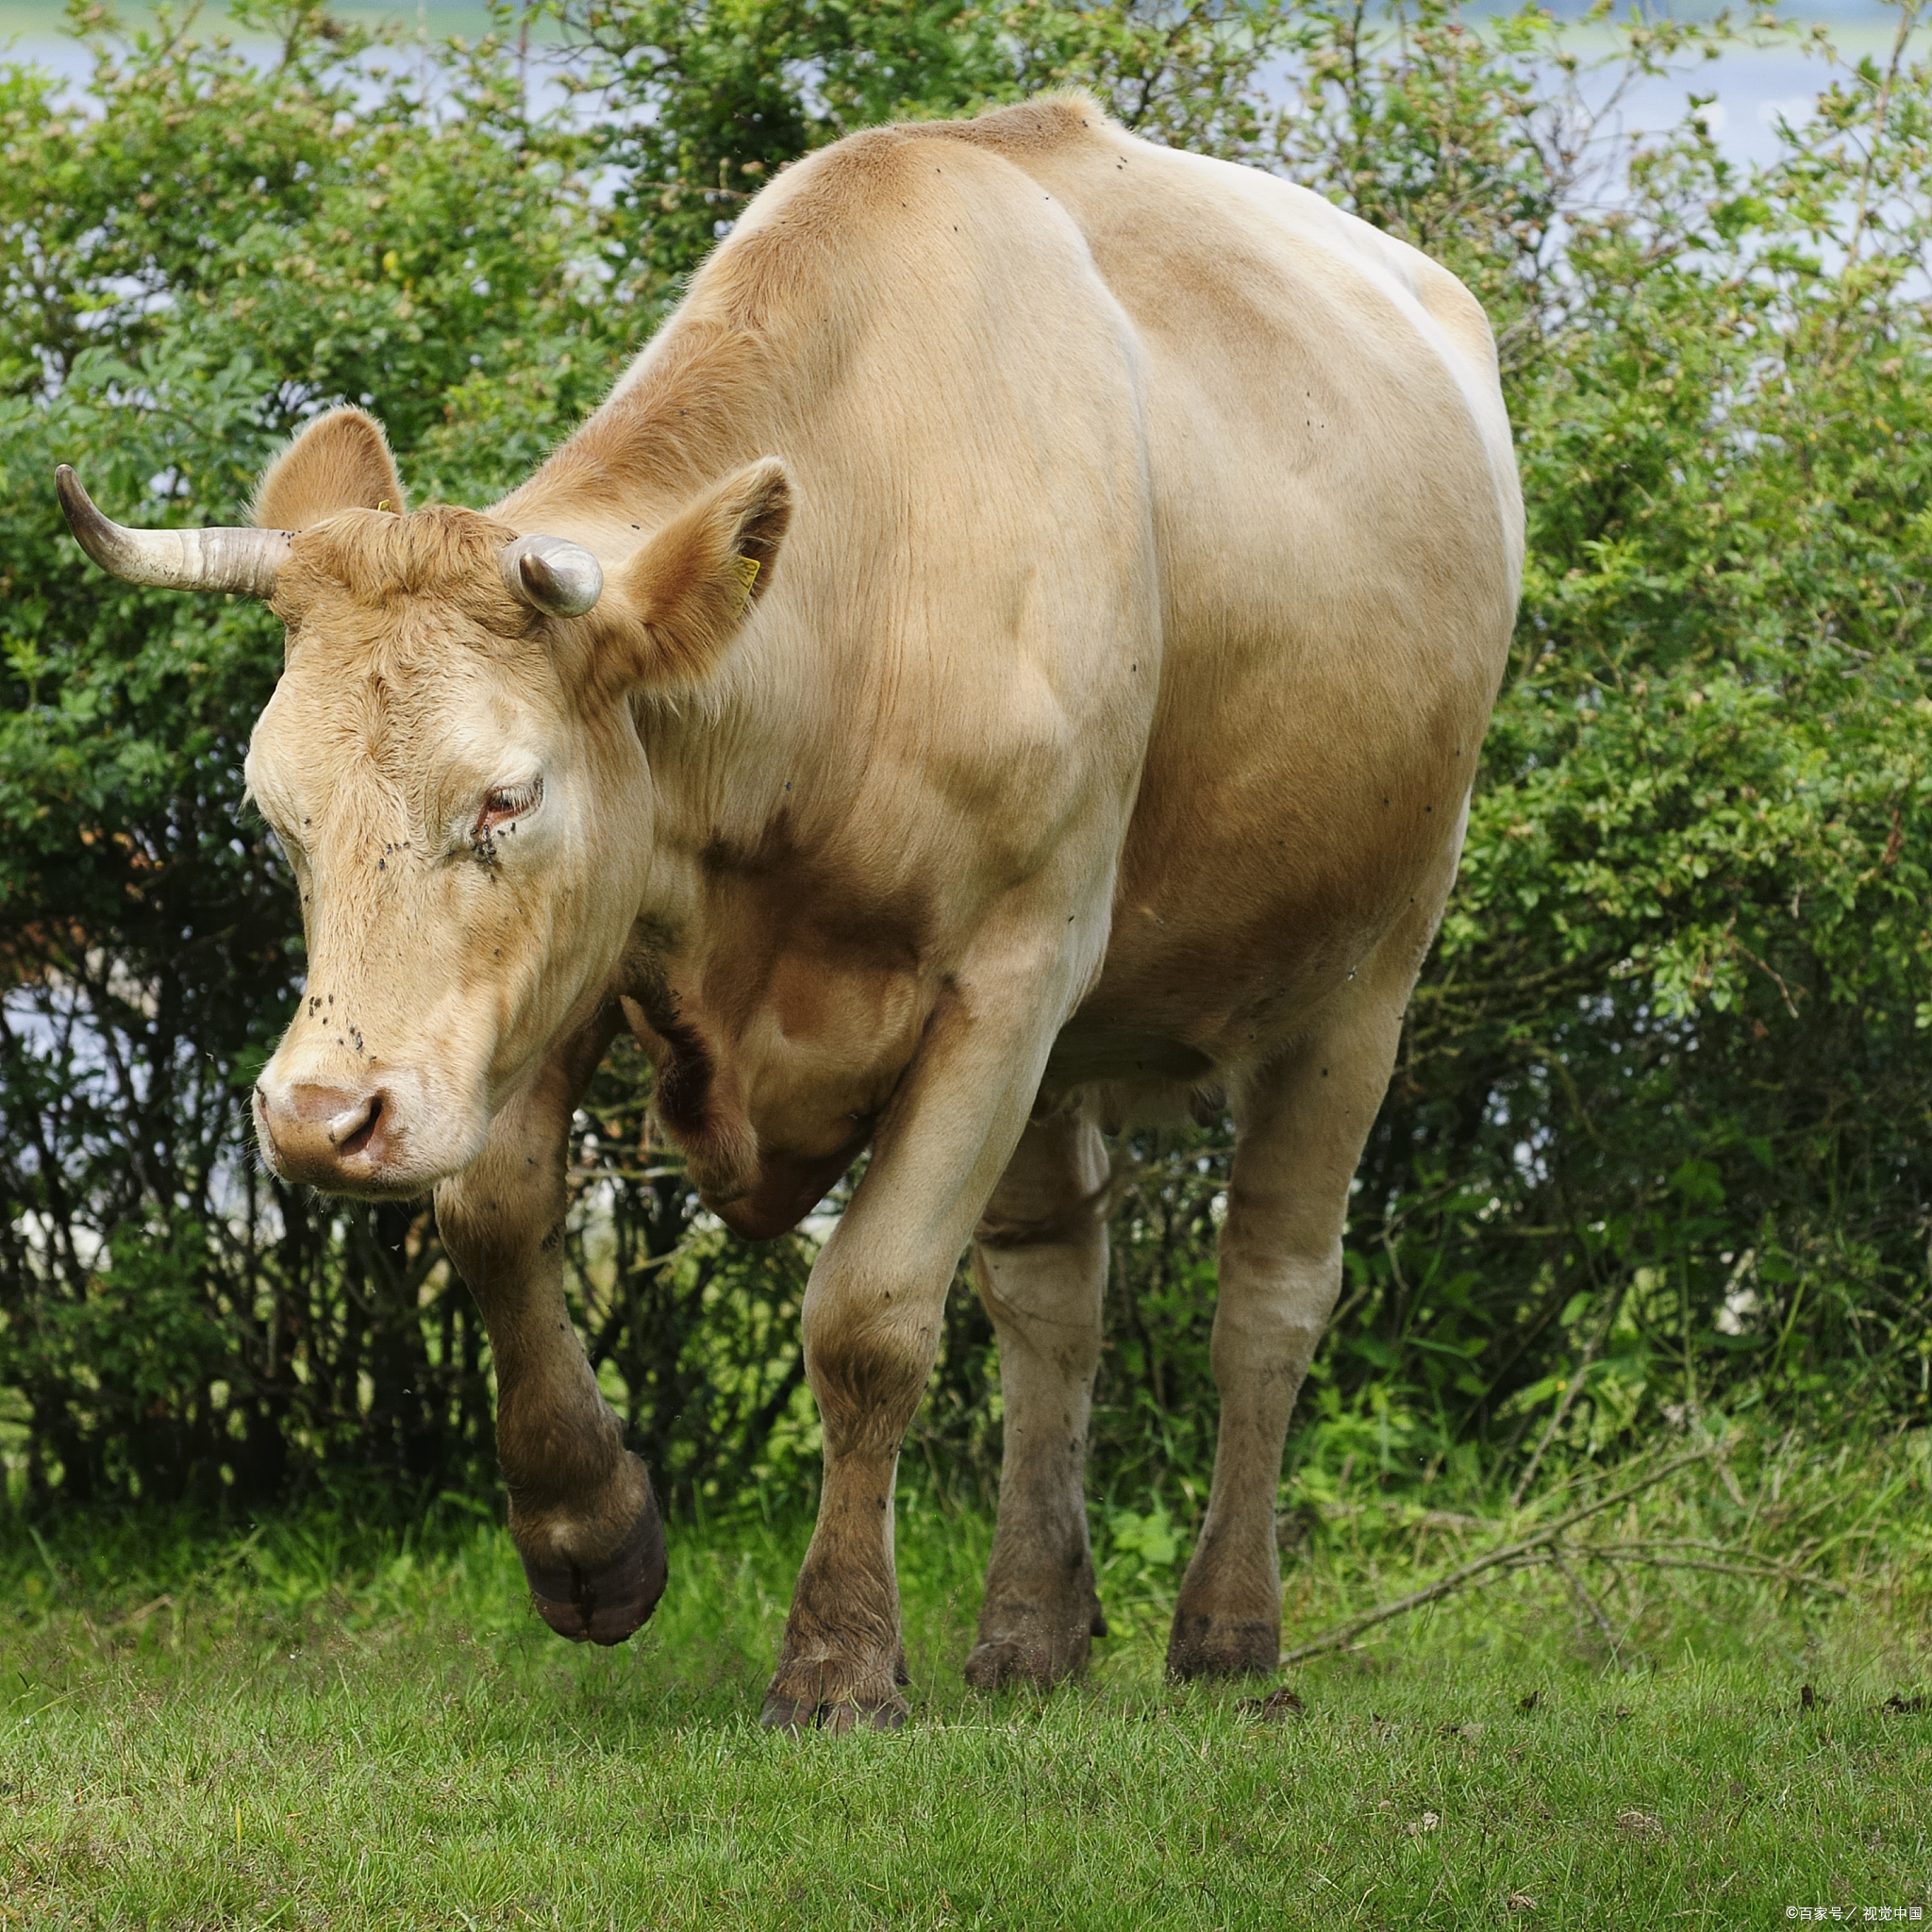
[614,456,792,684]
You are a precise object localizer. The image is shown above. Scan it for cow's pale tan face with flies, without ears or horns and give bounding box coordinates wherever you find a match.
[247,510,649,1196]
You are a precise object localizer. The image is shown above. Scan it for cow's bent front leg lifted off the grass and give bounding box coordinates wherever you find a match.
[437,1018,665,1644]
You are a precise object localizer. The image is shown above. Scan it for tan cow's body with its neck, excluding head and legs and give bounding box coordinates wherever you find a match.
[496,107,1517,1233]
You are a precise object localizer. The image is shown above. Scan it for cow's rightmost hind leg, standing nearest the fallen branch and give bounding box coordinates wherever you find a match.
[1167,974,1410,1677]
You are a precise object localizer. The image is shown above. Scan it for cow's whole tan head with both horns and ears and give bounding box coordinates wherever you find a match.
[58,409,789,1198]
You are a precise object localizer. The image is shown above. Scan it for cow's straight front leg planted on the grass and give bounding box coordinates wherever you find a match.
[765,968,1071,1731]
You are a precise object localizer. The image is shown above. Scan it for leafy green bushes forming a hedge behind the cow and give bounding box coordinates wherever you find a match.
[0,0,1932,1507]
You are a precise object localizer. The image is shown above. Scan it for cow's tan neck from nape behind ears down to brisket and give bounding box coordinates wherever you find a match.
[496,288,950,1233]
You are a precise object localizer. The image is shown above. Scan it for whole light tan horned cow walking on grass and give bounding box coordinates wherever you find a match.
[58,94,1523,1731]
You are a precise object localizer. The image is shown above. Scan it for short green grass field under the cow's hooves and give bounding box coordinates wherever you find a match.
[0,1440,1932,1932]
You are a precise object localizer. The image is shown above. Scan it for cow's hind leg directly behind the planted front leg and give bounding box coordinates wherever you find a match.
[966,1117,1108,1690]
